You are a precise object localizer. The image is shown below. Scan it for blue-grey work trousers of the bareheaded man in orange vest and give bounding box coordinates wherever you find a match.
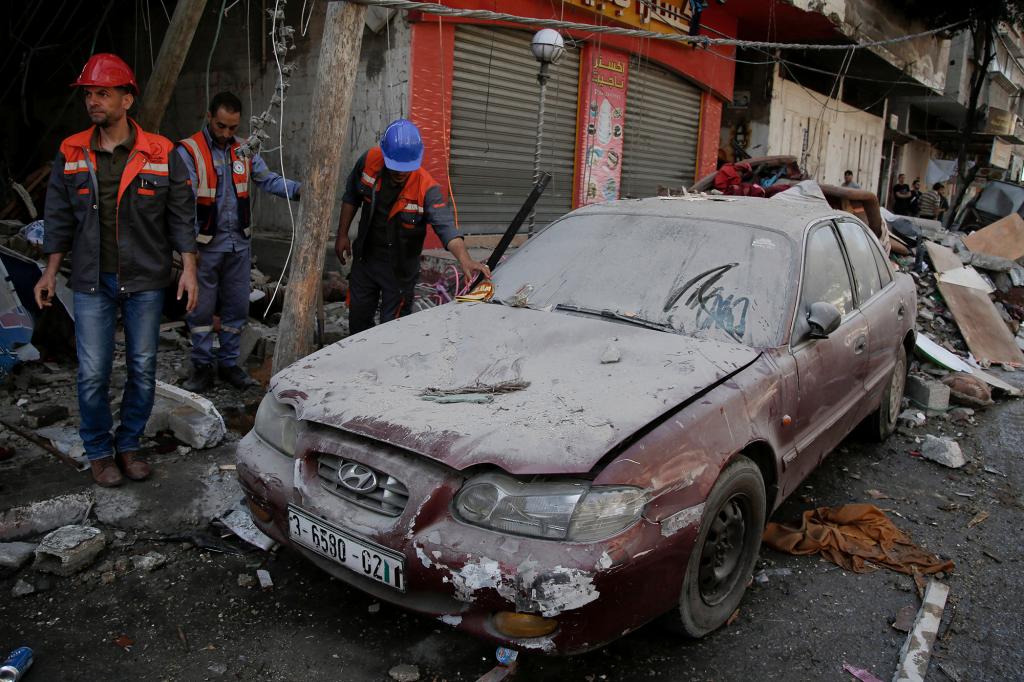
[188,248,252,367]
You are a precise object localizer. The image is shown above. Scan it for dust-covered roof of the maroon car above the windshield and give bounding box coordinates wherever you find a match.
[570,193,859,243]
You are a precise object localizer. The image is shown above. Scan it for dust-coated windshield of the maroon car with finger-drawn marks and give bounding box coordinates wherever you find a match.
[494,213,793,348]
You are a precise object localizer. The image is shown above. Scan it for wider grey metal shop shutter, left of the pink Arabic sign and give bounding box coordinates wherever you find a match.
[449,26,580,235]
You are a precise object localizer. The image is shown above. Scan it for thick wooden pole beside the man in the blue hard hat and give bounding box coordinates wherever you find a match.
[273,2,367,372]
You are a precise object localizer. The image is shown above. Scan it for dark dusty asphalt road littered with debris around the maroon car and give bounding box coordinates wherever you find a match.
[0,378,1024,682]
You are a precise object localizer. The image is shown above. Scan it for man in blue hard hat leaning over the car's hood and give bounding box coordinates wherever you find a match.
[334,119,490,334]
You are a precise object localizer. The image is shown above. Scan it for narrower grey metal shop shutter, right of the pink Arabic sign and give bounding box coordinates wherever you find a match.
[622,55,700,199]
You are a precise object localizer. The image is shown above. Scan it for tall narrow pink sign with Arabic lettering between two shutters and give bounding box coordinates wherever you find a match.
[575,44,630,206]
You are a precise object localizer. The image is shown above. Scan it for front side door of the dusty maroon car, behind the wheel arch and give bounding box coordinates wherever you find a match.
[786,221,868,493]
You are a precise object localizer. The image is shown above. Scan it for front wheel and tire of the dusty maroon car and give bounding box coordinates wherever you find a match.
[674,457,766,638]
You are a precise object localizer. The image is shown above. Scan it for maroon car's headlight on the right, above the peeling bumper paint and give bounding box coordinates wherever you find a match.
[455,474,647,543]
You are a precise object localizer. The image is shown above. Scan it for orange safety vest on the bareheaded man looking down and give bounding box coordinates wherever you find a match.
[181,130,252,244]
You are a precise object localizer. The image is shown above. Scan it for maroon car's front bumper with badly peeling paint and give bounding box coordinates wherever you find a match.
[238,428,699,654]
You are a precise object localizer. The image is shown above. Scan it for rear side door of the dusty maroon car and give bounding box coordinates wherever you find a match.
[837,219,907,417]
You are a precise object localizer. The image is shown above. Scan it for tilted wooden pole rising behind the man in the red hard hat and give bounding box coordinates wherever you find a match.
[138,0,206,132]
